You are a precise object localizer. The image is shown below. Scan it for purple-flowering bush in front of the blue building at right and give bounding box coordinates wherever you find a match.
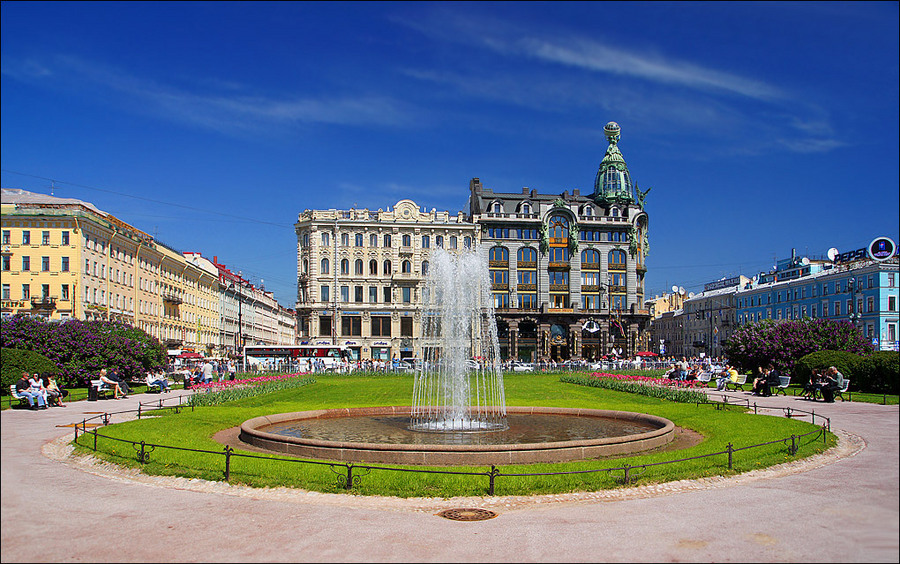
[725,317,872,374]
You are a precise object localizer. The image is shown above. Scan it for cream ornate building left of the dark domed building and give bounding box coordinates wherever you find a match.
[294,200,479,360]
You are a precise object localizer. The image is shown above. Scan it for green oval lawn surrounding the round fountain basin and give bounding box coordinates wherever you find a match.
[72,373,835,497]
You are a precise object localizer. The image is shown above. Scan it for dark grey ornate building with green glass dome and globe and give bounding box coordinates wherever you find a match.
[469,122,650,361]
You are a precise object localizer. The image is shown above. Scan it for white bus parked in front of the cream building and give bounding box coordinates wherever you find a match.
[244,345,351,372]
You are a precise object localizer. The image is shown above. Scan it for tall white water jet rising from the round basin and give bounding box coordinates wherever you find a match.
[410,249,507,432]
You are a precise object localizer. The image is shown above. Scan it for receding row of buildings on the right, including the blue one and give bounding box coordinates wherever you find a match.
[648,241,900,357]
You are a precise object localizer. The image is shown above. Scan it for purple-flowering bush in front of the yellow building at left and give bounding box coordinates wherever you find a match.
[0,315,166,385]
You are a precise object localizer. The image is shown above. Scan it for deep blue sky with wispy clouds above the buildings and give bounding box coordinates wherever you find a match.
[0,2,900,307]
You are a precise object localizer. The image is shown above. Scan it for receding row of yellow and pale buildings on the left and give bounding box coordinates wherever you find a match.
[0,189,296,357]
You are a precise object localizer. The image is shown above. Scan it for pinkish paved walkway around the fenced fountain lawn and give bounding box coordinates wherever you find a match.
[0,392,900,562]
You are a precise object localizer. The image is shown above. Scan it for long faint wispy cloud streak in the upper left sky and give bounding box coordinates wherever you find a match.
[3,56,414,133]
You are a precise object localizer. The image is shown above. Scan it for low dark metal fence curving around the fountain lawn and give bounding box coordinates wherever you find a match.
[75,395,831,495]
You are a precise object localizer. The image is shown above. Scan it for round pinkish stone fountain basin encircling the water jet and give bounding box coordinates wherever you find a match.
[240,406,675,466]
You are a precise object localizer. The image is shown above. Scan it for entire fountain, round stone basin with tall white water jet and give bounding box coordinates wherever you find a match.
[240,249,675,465]
